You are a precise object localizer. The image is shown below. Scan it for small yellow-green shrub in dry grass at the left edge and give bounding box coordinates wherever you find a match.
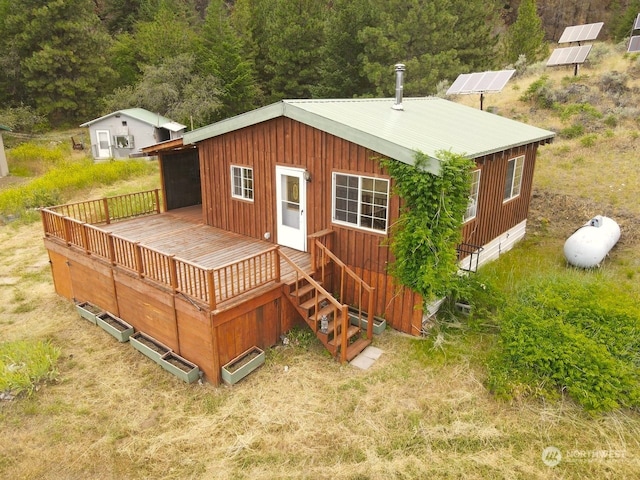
[0,341,60,396]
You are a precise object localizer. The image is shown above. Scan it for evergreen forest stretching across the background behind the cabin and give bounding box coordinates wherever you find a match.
[0,0,640,132]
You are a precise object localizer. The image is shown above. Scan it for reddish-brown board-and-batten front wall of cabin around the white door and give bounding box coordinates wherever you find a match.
[198,117,422,334]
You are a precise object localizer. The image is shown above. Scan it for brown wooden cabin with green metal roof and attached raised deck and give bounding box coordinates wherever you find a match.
[43,98,554,384]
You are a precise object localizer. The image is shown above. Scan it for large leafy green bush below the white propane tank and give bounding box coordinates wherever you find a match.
[488,275,640,411]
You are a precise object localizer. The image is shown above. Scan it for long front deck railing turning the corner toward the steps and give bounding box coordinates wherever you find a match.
[41,192,280,310]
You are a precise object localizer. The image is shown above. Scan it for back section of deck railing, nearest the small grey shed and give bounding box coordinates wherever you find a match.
[47,188,160,225]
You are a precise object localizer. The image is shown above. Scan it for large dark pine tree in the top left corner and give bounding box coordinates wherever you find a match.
[0,0,113,125]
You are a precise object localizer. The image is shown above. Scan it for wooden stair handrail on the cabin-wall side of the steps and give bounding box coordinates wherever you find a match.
[311,230,376,340]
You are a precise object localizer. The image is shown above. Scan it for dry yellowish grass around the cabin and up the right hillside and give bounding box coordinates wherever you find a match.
[0,46,640,480]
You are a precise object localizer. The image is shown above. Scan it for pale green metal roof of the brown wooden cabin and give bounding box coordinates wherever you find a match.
[184,97,555,172]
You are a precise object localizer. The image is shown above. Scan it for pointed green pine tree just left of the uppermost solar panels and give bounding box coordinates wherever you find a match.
[505,0,548,63]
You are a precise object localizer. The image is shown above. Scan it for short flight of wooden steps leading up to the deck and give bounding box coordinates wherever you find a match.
[284,276,371,362]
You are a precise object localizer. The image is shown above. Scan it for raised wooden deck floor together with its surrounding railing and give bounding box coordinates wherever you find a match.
[41,191,310,311]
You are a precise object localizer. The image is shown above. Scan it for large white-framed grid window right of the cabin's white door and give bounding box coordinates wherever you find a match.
[332,172,389,233]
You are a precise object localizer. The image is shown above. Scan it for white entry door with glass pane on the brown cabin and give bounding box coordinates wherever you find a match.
[276,167,307,252]
